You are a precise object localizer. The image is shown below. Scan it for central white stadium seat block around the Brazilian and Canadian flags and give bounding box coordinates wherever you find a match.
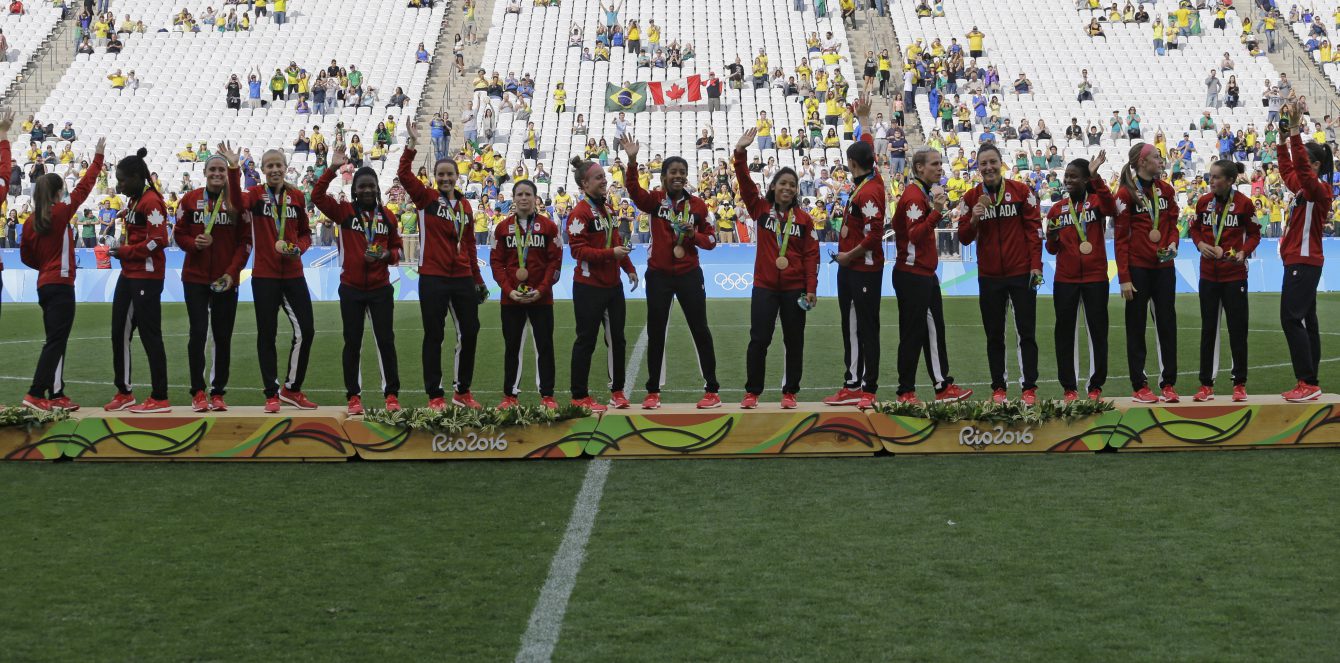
[482,0,860,196]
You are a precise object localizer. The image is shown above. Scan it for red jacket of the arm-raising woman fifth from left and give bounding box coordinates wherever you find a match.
[312,167,402,291]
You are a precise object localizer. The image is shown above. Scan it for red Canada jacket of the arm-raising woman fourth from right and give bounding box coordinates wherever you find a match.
[1043,177,1116,283]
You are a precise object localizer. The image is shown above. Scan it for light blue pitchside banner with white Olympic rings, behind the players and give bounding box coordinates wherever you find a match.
[0,237,1340,303]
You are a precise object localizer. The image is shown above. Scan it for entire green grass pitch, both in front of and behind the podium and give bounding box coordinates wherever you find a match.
[0,295,1340,662]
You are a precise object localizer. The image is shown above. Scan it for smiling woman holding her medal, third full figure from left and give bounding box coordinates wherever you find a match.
[173,143,251,413]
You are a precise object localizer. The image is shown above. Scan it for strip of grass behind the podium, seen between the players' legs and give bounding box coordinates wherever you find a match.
[0,295,1340,406]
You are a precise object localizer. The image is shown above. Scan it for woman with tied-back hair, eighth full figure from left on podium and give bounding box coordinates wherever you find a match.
[568,157,638,413]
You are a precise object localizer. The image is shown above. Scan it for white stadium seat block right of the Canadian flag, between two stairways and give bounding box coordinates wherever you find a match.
[891,0,1278,179]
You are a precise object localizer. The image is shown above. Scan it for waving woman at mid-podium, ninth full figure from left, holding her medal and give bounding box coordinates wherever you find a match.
[622,135,721,410]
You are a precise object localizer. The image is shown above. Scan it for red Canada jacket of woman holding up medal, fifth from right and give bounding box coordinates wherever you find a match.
[958,179,1043,279]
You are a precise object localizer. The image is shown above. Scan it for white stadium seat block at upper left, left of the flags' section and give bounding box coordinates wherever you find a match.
[20,0,448,202]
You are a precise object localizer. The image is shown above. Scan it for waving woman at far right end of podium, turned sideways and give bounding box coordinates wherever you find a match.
[1277,107,1335,403]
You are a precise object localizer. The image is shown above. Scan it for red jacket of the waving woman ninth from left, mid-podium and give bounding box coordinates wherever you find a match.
[623,158,717,276]
